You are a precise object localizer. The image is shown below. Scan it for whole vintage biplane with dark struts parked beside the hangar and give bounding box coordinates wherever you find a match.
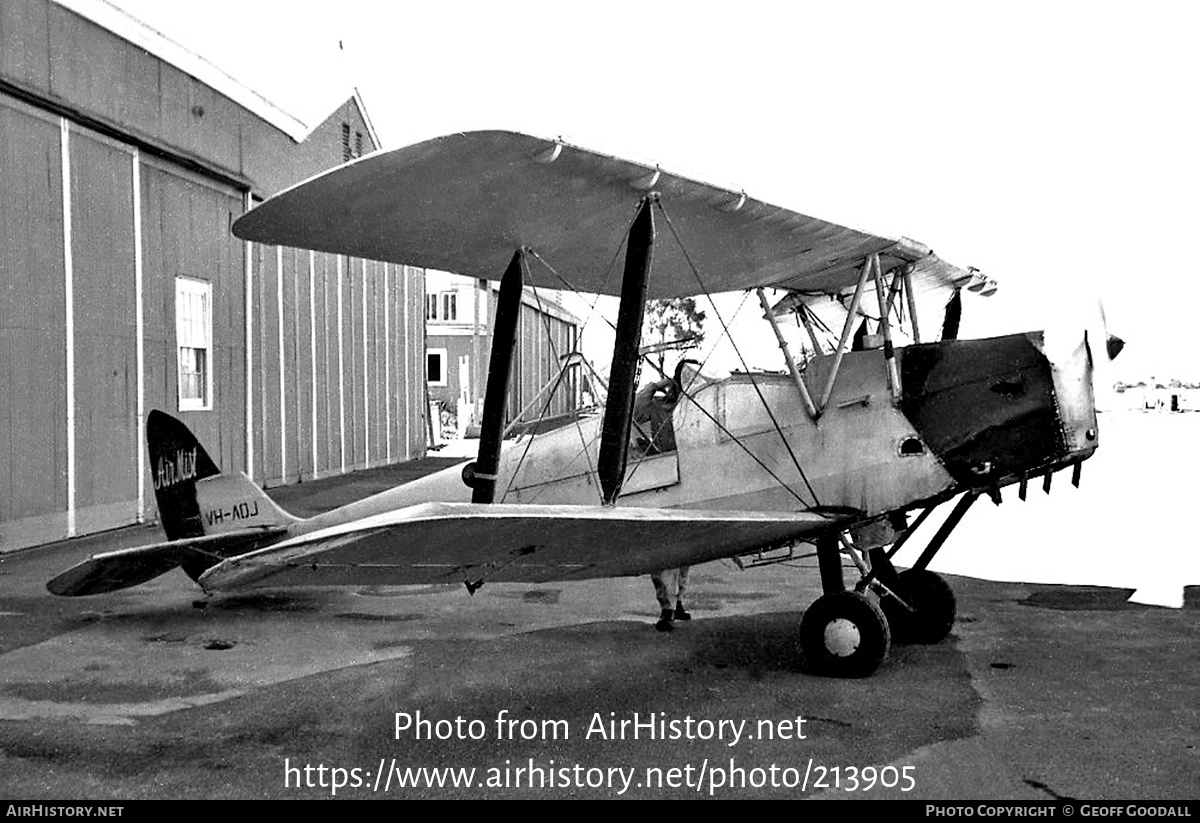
[48,132,1113,677]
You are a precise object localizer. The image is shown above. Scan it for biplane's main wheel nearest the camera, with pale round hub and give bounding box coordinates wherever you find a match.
[800,591,892,678]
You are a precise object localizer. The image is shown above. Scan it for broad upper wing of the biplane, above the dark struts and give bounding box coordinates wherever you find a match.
[233,132,984,303]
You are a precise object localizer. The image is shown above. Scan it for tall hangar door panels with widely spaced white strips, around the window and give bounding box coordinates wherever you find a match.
[0,95,245,552]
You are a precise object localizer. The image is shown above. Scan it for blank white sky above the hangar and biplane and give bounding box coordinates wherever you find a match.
[100,0,1200,380]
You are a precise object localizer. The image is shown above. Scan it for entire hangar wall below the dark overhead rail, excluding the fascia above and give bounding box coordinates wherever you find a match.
[0,86,425,551]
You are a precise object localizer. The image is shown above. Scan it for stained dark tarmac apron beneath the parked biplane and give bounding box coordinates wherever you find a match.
[0,458,1200,801]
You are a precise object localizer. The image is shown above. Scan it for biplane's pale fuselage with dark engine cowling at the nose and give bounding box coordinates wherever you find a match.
[295,332,1097,542]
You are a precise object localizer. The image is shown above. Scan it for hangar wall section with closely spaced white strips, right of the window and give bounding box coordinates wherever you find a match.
[252,246,425,485]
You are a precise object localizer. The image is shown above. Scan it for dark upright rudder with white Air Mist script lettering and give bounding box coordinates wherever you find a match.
[146,410,221,540]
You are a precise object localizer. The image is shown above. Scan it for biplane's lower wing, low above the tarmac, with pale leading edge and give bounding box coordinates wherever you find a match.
[199,503,836,589]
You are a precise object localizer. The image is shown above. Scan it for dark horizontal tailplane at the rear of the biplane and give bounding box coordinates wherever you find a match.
[46,528,287,597]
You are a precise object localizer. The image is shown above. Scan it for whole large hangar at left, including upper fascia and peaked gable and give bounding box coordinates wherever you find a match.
[0,0,425,552]
